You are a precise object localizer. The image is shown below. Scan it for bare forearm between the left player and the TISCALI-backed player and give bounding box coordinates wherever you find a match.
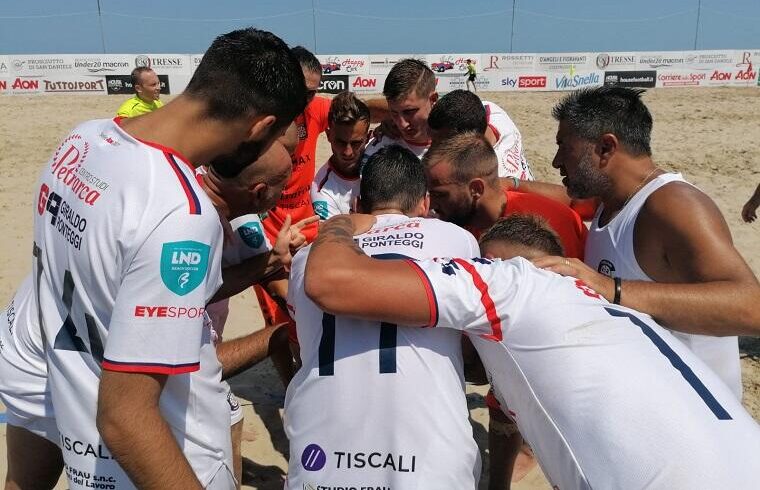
[221,324,288,379]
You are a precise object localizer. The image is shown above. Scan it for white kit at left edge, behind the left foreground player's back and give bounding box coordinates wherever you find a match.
[0,275,58,444]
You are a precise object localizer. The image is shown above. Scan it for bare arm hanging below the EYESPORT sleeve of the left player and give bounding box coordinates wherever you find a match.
[97,370,202,489]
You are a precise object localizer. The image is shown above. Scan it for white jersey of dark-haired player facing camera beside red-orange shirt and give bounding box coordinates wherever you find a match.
[311,160,359,220]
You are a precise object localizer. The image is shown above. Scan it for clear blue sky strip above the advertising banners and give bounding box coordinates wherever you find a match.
[0,0,760,54]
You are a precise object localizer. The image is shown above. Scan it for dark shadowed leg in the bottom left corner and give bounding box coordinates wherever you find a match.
[5,425,63,490]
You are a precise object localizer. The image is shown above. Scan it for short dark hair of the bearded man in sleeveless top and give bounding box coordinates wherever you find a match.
[552,86,652,156]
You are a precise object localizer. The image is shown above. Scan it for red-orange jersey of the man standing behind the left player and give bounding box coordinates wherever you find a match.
[262,97,330,243]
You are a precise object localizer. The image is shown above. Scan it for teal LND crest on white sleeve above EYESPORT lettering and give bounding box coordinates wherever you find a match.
[161,240,211,296]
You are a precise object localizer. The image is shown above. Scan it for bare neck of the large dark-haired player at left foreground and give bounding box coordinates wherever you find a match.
[121,95,247,168]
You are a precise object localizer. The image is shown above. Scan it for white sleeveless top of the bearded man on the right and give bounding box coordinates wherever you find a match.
[584,173,742,399]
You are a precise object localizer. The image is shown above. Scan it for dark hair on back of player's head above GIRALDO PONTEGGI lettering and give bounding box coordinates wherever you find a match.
[359,145,427,213]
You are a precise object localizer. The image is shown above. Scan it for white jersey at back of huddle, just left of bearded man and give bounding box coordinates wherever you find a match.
[483,101,533,180]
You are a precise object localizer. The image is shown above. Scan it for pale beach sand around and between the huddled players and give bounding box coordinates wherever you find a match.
[0,88,760,490]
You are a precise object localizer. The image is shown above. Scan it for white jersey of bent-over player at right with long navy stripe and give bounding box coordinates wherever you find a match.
[409,258,760,490]
